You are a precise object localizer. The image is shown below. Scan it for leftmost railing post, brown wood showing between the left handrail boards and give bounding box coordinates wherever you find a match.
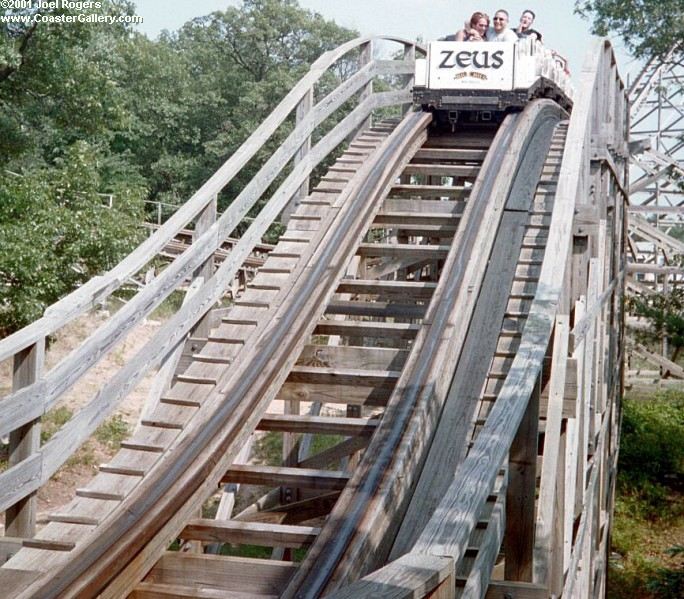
[5,339,45,538]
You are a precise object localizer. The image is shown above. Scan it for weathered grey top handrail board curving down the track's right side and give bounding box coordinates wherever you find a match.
[408,41,598,572]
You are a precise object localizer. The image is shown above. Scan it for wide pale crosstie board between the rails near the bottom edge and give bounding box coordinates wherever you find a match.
[145,552,297,595]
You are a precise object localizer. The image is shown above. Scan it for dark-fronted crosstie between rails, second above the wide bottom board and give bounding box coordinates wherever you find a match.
[221,465,349,491]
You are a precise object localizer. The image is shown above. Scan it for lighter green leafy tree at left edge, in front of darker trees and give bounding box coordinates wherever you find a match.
[0,142,144,336]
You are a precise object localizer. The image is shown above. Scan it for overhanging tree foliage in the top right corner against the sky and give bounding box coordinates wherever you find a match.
[575,0,684,58]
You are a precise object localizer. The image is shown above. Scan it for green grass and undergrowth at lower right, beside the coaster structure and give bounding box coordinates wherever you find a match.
[607,391,684,599]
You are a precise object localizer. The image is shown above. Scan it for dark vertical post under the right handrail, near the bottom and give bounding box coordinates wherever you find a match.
[504,375,541,582]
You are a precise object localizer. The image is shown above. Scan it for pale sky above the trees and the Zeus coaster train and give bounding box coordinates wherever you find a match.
[134,0,639,80]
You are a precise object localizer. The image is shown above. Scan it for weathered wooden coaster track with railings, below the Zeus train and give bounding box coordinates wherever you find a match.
[0,39,628,599]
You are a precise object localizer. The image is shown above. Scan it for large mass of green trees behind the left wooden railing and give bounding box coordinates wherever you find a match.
[0,0,355,336]
